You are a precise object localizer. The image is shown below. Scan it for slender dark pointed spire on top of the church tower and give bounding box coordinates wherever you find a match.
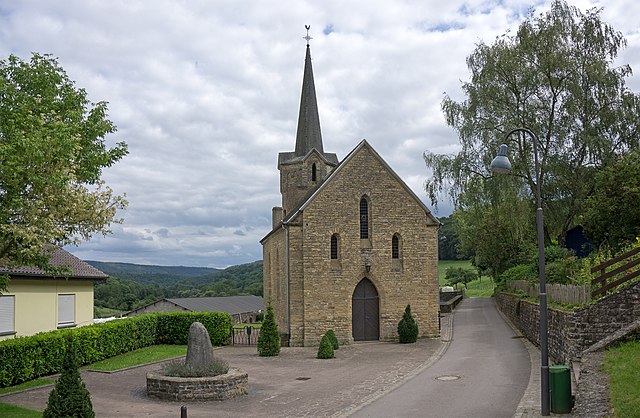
[295,43,324,157]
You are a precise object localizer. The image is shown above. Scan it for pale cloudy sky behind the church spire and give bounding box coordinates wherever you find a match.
[0,0,640,267]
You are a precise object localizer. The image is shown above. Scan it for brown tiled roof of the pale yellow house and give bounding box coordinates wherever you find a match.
[0,247,109,280]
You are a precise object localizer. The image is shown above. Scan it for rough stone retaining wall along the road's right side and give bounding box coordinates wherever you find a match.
[495,282,640,363]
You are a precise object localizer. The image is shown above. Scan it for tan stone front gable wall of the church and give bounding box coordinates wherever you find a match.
[290,147,439,345]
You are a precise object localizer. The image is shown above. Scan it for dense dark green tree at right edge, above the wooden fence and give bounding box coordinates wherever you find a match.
[583,149,640,249]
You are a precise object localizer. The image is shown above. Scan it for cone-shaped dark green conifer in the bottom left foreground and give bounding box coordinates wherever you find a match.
[42,334,95,418]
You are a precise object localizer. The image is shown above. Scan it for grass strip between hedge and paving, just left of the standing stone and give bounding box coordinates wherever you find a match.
[84,345,187,372]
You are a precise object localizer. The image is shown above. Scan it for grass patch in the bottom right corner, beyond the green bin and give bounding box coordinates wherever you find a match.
[604,341,640,418]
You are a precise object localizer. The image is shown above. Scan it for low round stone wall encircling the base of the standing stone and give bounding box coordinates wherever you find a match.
[147,368,249,401]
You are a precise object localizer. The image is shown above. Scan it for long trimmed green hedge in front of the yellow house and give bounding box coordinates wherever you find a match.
[0,312,231,387]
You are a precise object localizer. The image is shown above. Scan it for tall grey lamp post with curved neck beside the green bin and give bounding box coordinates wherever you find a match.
[490,128,549,416]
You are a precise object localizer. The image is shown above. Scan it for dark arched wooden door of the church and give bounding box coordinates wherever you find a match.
[351,278,380,341]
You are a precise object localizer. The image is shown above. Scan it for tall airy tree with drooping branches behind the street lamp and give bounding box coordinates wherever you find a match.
[424,1,640,272]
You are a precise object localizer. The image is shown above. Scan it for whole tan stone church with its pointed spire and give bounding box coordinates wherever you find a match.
[260,43,439,346]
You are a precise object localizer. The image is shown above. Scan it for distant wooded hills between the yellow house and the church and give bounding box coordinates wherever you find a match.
[87,261,262,311]
